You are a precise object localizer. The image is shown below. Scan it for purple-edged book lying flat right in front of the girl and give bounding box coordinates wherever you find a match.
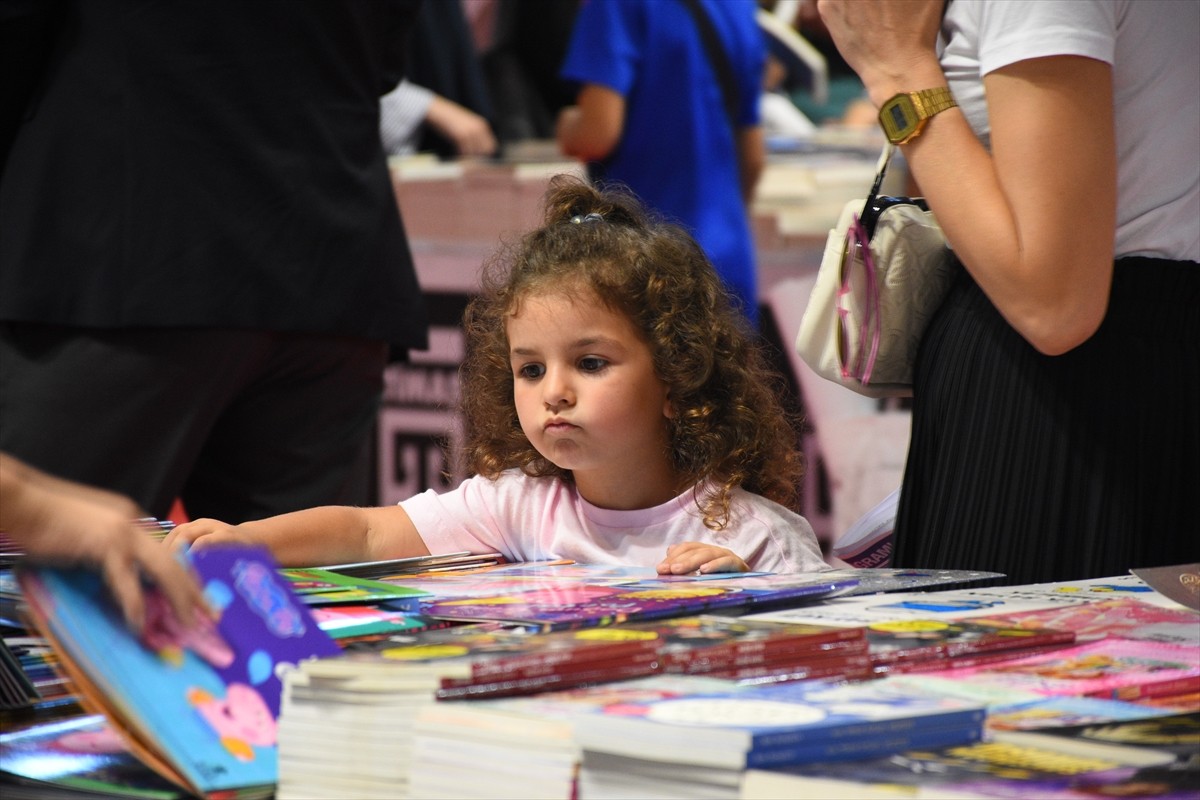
[421,573,854,631]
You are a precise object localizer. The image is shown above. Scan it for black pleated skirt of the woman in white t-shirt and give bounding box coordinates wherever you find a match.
[894,258,1200,584]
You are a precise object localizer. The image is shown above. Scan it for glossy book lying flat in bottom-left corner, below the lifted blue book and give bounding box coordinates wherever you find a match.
[0,715,188,800]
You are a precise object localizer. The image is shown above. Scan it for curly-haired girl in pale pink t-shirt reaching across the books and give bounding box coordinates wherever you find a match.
[167,176,826,575]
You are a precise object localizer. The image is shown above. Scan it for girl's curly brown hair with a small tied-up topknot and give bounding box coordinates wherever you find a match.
[462,175,800,530]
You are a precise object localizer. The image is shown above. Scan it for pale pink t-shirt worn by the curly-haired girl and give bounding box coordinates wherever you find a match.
[400,469,829,572]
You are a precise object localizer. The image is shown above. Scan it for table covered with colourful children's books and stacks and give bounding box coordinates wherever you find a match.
[0,548,1200,800]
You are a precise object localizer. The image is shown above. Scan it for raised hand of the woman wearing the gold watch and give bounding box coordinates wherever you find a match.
[817,0,946,107]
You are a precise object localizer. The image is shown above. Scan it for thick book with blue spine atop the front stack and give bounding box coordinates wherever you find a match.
[576,678,985,770]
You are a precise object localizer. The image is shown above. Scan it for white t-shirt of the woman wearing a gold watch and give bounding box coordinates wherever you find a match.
[941,0,1200,261]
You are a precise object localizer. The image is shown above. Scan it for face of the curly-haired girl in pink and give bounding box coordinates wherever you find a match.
[506,294,680,509]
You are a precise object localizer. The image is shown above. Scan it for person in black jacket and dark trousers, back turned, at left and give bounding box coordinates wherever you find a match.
[0,0,427,521]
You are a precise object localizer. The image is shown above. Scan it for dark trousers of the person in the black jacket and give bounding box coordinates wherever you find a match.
[0,323,386,523]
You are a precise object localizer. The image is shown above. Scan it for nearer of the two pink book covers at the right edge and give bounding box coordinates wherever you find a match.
[928,638,1200,699]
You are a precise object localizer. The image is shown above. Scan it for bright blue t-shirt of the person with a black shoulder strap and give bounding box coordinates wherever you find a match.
[562,0,767,317]
